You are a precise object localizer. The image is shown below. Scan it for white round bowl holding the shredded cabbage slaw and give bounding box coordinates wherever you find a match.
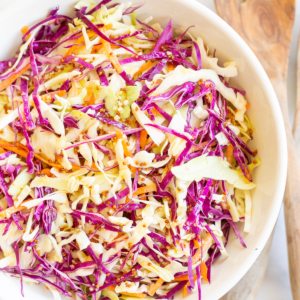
[0,0,287,300]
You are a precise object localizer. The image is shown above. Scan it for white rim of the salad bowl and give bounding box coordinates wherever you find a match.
[0,0,288,300]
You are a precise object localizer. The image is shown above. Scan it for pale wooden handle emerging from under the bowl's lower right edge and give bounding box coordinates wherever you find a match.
[220,230,274,300]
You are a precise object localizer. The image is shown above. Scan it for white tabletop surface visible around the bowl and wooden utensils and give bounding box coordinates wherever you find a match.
[0,0,300,300]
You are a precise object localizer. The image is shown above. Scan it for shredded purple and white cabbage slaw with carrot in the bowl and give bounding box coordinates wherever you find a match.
[0,0,261,300]
